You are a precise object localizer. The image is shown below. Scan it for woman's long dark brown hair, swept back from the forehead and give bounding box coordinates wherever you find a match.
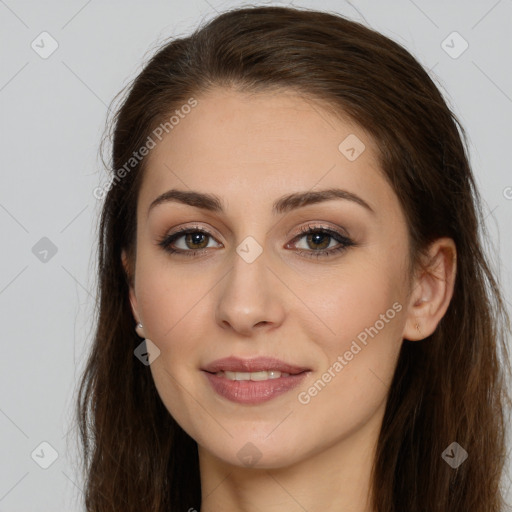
[77,7,510,512]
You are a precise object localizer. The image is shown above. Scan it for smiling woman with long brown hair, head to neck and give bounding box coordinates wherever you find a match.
[78,7,509,512]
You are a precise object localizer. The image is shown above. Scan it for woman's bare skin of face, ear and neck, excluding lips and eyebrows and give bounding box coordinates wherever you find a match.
[123,88,455,512]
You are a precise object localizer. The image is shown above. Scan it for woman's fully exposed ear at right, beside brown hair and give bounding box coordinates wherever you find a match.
[403,237,457,341]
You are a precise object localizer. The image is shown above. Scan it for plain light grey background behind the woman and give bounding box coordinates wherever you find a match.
[0,0,512,512]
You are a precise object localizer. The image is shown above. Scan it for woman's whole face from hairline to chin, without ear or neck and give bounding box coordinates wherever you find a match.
[124,89,416,468]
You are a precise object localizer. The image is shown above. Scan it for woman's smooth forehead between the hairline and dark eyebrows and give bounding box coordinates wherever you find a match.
[139,88,389,216]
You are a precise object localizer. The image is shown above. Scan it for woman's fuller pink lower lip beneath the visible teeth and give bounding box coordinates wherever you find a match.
[203,372,309,404]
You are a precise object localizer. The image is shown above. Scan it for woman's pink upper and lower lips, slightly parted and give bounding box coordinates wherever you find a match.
[203,357,309,405]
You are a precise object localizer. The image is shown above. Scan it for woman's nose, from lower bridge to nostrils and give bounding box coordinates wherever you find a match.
[215,247,285,336]
